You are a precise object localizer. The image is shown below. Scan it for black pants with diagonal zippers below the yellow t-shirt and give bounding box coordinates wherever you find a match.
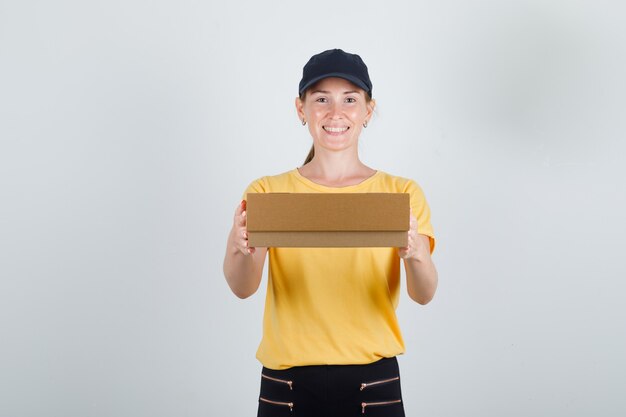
[257,357,404,417]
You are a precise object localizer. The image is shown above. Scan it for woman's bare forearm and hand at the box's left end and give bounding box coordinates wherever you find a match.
[224,200,267,298]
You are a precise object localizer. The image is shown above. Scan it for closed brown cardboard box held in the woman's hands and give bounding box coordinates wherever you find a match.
[246,193,410,247]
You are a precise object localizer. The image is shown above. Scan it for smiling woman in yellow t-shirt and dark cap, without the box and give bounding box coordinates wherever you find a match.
[224,49,438,417]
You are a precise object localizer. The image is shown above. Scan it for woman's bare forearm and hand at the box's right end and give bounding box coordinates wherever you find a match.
[398,214,439,305]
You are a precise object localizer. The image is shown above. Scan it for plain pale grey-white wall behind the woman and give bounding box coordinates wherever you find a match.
[0,0,626,417]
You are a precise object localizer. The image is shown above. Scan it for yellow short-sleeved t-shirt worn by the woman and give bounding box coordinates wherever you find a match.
[246,169,435,369]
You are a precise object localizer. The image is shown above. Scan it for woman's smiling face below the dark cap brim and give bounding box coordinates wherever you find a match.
[296,77,374,151]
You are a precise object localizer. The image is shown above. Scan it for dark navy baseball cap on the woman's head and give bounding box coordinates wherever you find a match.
[298,49,372,97]
